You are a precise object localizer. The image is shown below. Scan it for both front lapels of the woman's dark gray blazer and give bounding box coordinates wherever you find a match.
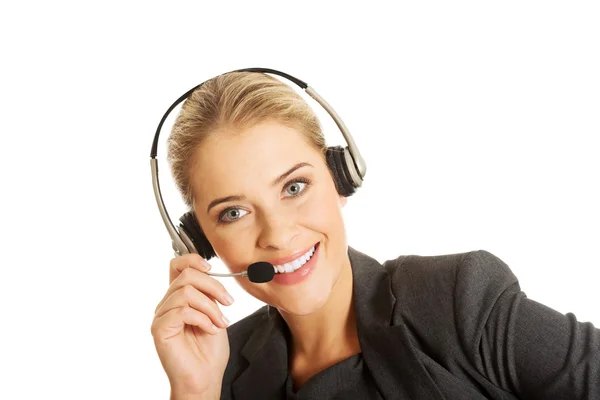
[232,247,443,399]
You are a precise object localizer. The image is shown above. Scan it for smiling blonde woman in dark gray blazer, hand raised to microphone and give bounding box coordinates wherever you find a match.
[152,72,600,399]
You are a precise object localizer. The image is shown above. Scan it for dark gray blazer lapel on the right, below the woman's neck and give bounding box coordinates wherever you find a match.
[348,248,444,400]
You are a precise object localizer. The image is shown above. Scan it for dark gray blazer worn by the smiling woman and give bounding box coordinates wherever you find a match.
[221,247,600,400]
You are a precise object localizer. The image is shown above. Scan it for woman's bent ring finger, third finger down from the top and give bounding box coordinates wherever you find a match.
[156,285,228,328]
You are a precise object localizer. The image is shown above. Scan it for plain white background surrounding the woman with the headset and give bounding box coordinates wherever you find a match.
[0,1,600,399]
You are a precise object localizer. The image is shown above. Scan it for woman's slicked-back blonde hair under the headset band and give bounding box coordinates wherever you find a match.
[167,72,327,209]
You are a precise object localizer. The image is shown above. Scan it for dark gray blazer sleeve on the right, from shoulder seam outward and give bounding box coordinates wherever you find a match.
[455,250,600,400]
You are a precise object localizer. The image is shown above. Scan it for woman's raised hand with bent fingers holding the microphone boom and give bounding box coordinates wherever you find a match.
[151,254,233,398]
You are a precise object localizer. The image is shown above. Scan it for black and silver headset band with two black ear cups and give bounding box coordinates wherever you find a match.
[150,68,367,260]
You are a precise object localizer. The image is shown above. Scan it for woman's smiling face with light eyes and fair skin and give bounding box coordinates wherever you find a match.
[192,121,349,315]
